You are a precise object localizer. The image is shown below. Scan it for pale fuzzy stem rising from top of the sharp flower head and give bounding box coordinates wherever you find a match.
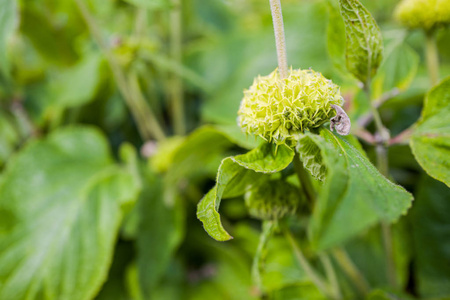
[270,0,288,78]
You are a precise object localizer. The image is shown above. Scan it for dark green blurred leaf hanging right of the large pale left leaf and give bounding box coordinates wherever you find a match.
[137,169,186,299]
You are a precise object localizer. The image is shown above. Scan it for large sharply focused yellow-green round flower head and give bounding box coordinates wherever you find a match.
[238,69,344,145]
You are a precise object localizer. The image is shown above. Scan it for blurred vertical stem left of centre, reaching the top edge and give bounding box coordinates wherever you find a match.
[170,0,186,135]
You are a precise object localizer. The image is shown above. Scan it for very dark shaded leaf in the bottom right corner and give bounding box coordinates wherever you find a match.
[410,177,450,299]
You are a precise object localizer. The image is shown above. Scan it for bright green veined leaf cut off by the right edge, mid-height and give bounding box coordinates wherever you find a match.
[410,78,450,186]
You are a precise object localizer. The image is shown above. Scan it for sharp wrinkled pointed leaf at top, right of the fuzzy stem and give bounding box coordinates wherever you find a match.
[339,0,383,84]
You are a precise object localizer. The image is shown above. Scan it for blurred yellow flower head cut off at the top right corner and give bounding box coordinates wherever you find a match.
[395,0,450,31]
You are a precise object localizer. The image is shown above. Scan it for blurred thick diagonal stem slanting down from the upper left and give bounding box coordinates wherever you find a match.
[74,0,165,140]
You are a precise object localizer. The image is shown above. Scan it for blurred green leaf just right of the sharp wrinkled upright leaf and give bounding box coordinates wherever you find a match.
[372,43,419,99]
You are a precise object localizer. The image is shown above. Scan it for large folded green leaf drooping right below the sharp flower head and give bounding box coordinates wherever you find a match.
[299,129,413,249]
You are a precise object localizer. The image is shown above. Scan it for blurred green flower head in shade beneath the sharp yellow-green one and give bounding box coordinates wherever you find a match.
[245,180,299,220]
